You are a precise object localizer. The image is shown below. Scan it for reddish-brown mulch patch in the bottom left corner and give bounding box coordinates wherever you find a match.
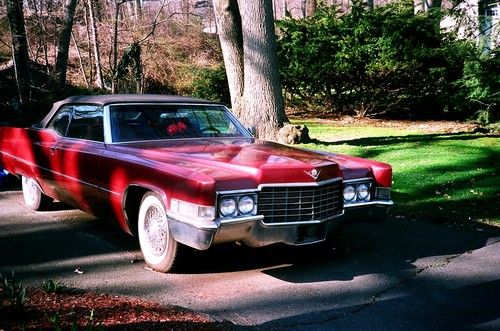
[0,289,231,330]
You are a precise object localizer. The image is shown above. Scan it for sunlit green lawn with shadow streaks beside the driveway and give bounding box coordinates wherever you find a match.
[301,122,500,226]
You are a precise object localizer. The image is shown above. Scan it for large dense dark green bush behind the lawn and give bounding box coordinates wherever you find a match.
[278,3,494,118]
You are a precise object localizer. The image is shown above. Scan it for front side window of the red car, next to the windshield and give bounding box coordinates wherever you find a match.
[67,105,104,142]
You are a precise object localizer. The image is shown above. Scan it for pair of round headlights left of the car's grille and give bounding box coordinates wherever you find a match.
[218,194,257,217]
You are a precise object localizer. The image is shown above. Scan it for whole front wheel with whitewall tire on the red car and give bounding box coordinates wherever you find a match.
[138,192,178,272]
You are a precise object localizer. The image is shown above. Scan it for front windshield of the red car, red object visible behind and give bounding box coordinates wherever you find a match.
[109,104,250,142]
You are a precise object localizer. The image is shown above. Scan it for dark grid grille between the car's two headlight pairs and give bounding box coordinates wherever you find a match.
[257,181,343,223]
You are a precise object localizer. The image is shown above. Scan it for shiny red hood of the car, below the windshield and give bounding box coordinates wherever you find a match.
[110,138,341,190]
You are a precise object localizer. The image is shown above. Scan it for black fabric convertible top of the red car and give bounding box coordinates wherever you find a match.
[40,94,220,127]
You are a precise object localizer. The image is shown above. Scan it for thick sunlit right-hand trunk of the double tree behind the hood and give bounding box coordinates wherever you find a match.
[239,0,288,140]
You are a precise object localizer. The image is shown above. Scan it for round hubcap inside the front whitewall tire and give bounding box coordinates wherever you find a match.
[144,206,167,256]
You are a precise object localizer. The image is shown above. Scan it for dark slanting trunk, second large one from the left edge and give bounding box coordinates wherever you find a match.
[56,0,77,87]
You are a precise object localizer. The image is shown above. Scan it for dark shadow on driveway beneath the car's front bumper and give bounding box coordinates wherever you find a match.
[173,218,500,283]
